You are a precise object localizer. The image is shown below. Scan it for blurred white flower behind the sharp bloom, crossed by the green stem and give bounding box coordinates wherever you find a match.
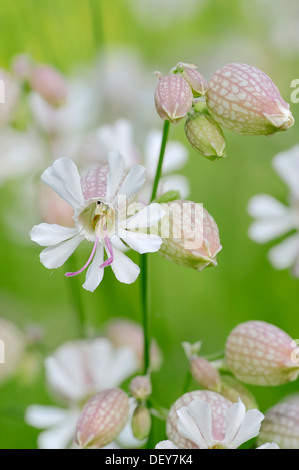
[82,119,189,201]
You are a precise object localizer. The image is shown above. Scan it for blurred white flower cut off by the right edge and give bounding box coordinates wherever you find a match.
[248,145,299,277]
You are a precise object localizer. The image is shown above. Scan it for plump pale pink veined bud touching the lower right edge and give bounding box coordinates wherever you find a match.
[225,321,299,385]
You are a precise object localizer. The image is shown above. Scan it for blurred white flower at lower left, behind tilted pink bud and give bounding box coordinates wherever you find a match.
[25,338,138,449]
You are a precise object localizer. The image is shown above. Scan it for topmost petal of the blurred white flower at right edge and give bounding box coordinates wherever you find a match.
[273,145,299,199]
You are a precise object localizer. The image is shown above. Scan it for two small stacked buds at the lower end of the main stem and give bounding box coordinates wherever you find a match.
[130,375,152,441]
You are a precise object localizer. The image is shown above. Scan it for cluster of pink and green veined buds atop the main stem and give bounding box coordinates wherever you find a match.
[155,62,294,161]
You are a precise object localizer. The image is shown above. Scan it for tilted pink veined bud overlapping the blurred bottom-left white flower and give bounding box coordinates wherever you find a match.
[76,388,129,449]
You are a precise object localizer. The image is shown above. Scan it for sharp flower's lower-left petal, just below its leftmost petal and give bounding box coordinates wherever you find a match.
[40,235,85,269]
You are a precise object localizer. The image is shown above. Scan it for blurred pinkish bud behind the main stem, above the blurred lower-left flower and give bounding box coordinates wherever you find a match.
[105,319,162,370]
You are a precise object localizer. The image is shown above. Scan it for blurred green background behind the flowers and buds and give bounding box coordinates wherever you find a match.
[0,0,299,448]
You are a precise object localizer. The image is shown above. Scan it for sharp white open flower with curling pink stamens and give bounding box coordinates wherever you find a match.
[30,153,164,292]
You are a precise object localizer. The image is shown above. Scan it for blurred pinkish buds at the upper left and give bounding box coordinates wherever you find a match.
[13,54,68,107]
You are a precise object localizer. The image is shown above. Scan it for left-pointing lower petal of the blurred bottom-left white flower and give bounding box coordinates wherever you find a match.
[25,405,69,429]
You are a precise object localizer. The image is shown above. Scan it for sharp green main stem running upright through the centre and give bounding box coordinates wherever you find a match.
[140,121,170,374]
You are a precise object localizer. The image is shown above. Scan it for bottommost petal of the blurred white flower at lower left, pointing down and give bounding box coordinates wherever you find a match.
[37,412,79,449]
